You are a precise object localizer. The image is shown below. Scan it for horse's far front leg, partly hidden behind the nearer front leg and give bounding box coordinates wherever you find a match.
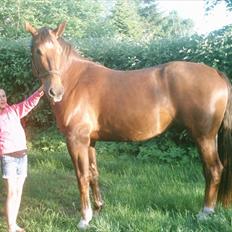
[89,147,103,211]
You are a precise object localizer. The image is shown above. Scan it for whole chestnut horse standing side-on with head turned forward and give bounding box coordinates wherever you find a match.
[26,23,232,228]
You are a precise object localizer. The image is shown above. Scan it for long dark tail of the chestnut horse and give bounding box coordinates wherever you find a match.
[218,72,232,207]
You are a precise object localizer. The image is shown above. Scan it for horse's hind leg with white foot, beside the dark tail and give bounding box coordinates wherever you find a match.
[197,136,223,219]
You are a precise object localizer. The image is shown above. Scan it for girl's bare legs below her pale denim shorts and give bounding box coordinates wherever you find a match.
[5,178,25,232]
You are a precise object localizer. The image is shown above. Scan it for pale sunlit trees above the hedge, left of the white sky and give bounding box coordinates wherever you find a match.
[0,0,193,40]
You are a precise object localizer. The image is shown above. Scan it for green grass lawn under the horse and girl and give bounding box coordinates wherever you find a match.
[0,131,232,232]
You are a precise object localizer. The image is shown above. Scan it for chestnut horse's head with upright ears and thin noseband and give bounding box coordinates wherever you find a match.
[25,22,66,102]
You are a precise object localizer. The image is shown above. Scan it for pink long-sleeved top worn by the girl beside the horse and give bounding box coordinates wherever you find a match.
[0,90,43,156]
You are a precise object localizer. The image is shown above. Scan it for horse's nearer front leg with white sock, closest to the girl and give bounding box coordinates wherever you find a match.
[67,136,93,229]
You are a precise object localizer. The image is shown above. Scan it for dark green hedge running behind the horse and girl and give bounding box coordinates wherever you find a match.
[0,26,232,130]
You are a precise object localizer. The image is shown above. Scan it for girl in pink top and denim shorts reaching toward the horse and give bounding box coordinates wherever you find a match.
[0,86,44,232]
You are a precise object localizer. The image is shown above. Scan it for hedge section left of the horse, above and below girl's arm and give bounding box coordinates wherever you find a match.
[0,39,53,127]
